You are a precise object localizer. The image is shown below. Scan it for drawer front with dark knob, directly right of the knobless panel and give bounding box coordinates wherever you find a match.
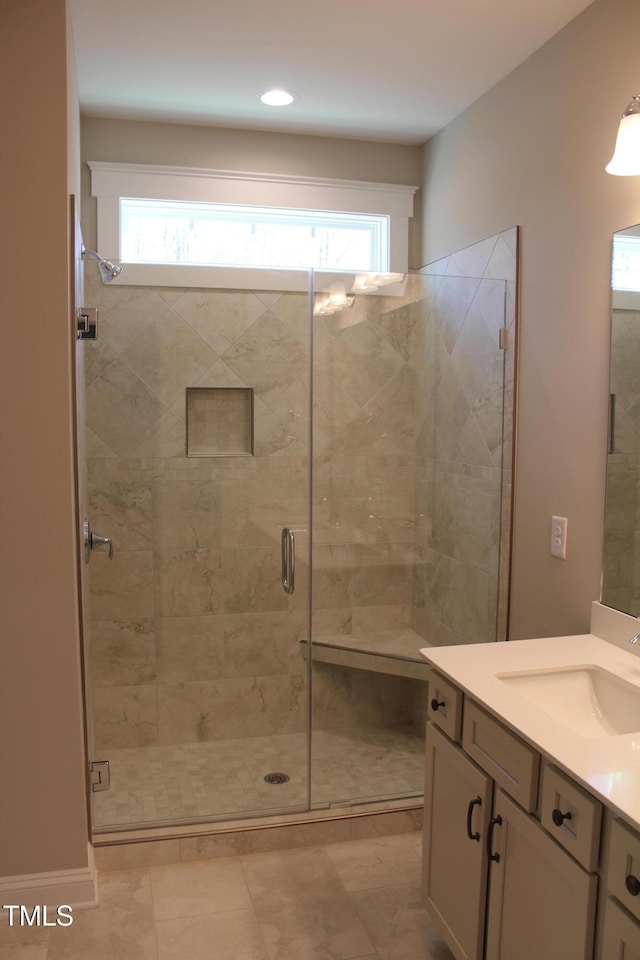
[540,764,602,872]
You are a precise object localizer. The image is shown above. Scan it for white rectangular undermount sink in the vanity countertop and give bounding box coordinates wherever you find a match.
[496,665,640,737]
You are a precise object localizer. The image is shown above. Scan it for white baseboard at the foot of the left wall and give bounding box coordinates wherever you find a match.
[0,844,98,918]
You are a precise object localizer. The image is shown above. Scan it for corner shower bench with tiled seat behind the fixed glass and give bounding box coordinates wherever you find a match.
[300,627,428,680]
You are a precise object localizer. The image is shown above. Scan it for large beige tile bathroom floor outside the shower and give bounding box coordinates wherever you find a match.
[0,833,453,960]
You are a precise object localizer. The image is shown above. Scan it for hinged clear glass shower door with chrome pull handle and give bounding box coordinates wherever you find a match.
[83,268,311,832]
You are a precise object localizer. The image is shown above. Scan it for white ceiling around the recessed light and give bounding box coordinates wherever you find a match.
[69,0,590,144]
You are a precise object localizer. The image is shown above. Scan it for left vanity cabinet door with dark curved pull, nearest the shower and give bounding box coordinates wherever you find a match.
[423,723,492,960]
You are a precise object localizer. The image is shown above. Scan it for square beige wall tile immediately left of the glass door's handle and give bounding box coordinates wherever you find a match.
[222,544,287,613]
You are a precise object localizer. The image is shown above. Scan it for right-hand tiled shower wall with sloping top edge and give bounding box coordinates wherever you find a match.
[412,228,517,645]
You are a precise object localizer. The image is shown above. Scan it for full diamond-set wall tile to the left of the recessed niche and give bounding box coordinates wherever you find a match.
[86,359,167,456]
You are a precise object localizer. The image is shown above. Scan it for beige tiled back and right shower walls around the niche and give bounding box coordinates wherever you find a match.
[87,230,516,749]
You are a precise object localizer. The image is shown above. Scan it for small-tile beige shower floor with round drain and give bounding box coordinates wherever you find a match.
[94,725,424,830]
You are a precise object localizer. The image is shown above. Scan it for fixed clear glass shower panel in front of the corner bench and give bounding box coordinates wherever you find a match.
[311,272,512,808]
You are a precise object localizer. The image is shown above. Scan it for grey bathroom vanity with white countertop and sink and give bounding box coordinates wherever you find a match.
[422,604,640,960]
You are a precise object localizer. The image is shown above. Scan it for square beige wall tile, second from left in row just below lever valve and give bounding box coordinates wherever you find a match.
[154,547,222,617]
